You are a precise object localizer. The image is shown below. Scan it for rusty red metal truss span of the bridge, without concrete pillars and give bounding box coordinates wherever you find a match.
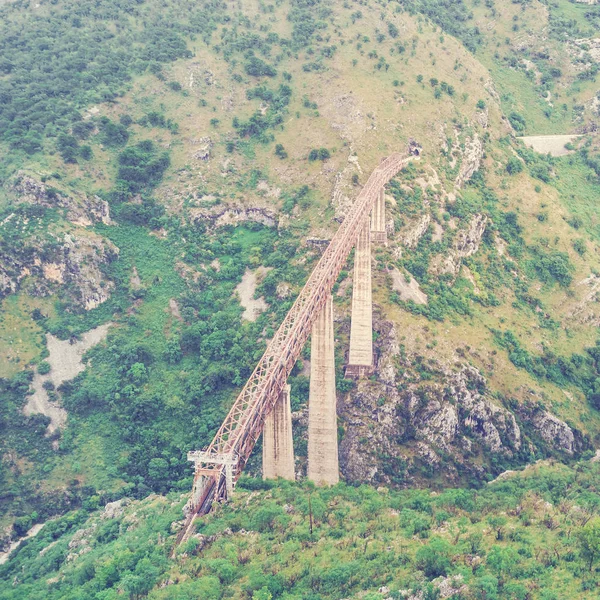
[178,148,418,542]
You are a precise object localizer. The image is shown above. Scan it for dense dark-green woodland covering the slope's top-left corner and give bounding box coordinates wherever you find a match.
[0,1,222,159]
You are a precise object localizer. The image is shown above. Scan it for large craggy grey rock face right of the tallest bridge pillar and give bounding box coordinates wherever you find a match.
[338,323,585,484]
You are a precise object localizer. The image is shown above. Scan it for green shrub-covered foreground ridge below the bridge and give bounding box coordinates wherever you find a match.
[0,463,600,600]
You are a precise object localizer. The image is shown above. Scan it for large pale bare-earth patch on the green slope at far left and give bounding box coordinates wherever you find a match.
[23,323,111,433]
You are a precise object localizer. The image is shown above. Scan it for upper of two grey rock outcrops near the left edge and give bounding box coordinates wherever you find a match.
[8,171,110,226]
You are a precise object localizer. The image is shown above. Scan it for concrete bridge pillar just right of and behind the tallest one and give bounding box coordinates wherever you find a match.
[346,223,373,377]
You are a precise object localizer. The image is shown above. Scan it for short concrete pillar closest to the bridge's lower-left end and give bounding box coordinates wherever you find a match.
[263,385,295,481]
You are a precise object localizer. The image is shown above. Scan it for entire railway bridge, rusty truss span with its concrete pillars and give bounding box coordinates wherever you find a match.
[178,142,419,543]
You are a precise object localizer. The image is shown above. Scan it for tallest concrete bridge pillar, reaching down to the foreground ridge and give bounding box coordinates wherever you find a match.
[308,296,340,485]
